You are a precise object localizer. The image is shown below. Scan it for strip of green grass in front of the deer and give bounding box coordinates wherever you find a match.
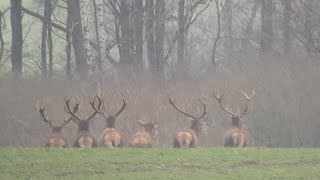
[0,148,320,179]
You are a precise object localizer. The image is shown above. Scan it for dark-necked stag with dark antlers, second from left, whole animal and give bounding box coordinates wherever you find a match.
[64,96,103,147]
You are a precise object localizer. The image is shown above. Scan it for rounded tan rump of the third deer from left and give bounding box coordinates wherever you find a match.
[99,128,122,147]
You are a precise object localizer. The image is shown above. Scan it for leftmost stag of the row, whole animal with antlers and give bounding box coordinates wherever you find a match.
[37,98,79,147]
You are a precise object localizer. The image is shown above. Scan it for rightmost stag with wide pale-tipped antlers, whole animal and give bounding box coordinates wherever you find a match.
[214,90,255,147]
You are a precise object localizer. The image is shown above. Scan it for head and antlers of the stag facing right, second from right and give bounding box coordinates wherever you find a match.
[169,98,207,134]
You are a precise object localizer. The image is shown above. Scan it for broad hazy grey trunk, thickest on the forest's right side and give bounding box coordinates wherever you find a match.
[261,0,273,55]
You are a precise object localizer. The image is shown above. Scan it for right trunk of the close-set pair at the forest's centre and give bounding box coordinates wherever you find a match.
[154,0,166,75]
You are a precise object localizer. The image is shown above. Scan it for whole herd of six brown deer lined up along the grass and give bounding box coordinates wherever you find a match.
[36,90,255,148]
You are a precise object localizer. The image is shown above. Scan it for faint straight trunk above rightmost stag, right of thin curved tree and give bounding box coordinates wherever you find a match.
[224,0,233,60]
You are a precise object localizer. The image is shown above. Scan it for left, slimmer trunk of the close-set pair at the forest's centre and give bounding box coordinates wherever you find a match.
[146,0,156,70]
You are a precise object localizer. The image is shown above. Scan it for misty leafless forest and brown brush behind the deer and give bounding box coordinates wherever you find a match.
[0,0,320,147]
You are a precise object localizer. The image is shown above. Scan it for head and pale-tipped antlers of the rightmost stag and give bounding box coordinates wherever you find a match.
[214,90,255,128]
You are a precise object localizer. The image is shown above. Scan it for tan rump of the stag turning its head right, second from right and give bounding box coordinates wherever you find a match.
[173,129,198,148]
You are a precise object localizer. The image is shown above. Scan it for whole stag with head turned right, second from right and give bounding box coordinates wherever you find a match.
[169,98,207,148]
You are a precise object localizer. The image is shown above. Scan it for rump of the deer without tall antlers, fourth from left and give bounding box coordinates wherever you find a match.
[129,132,152,148]
